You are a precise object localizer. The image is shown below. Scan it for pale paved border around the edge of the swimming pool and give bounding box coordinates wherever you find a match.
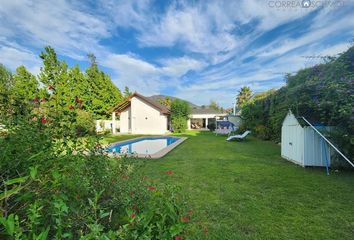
[106,136,188,159]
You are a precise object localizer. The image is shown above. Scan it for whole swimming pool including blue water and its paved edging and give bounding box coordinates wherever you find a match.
[106,136,185,158]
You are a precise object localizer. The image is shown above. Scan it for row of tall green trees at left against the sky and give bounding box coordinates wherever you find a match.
[0,46,123,118]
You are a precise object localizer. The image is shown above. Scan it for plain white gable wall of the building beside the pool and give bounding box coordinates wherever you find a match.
[130,97,168,134]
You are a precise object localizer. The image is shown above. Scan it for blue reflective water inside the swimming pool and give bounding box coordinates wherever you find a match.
[107,137,179,154]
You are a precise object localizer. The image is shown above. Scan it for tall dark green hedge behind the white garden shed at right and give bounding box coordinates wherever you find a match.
[242,47,354,157]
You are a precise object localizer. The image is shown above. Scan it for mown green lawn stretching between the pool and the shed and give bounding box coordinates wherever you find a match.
[102,132,354,239]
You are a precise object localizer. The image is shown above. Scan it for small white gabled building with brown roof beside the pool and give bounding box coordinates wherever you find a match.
[112,93,170,134]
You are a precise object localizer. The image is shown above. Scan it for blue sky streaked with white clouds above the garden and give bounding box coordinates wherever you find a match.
[0,0,354,107]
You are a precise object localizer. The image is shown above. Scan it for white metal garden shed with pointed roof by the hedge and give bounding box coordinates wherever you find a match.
[281,111,332,167]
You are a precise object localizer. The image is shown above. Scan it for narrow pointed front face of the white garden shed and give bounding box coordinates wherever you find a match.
[281,113,304,166]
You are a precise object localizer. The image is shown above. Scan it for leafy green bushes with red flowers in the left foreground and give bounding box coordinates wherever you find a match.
[0,97,188,239]
